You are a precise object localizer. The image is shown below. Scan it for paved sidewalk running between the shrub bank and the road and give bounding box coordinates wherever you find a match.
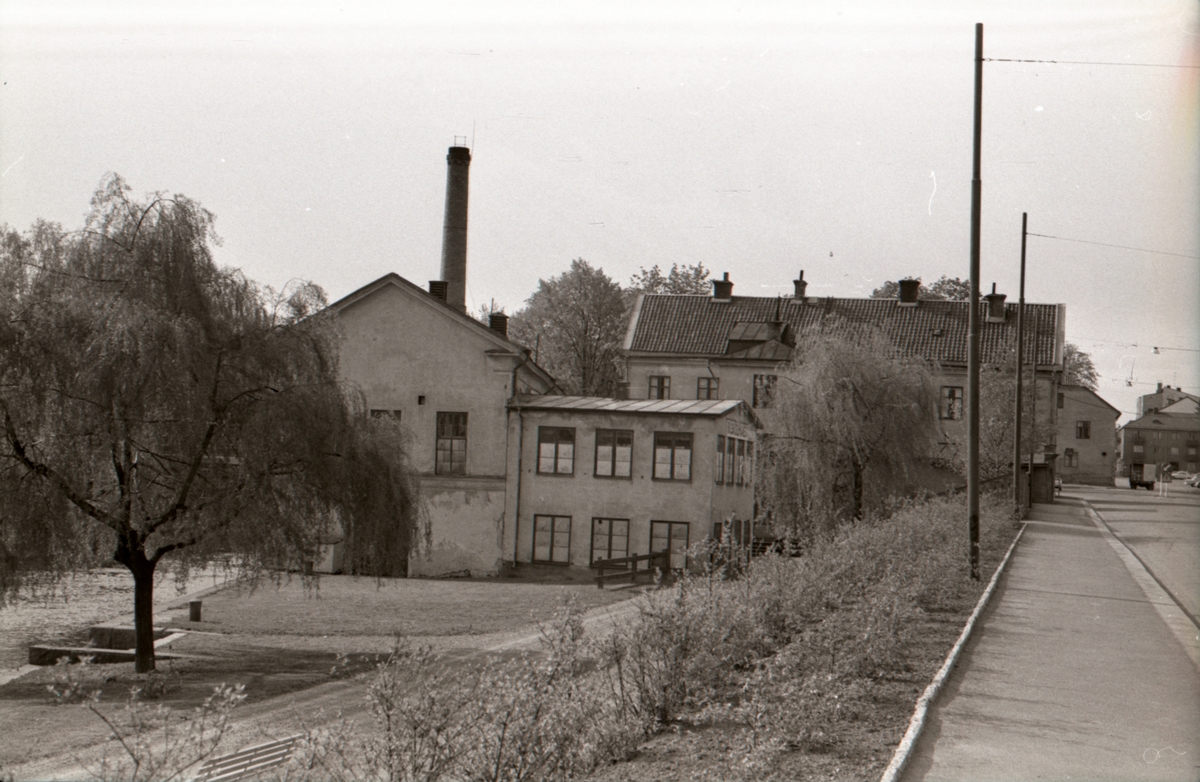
[902,500,1200,782]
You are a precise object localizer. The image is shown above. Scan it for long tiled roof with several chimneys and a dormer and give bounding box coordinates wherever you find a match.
[628,294,1062,365]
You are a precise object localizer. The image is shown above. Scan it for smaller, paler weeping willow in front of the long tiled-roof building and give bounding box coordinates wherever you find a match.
[760,333,938,539]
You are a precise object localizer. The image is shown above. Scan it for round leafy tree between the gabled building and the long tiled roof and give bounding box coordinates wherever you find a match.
[509,258,626,396]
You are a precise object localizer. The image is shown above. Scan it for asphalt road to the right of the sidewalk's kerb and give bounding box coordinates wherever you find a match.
[1063,481,1200,621]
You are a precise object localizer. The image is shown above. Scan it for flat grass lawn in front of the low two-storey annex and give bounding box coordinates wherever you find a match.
[159,576,636,637]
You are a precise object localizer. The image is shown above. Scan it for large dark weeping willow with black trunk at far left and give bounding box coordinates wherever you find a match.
[0,175,427,672]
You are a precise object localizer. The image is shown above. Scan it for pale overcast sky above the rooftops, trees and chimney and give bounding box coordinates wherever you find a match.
[0,0,1200,417]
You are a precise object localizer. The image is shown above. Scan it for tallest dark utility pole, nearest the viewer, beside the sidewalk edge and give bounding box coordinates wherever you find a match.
[967,23,983,581]
